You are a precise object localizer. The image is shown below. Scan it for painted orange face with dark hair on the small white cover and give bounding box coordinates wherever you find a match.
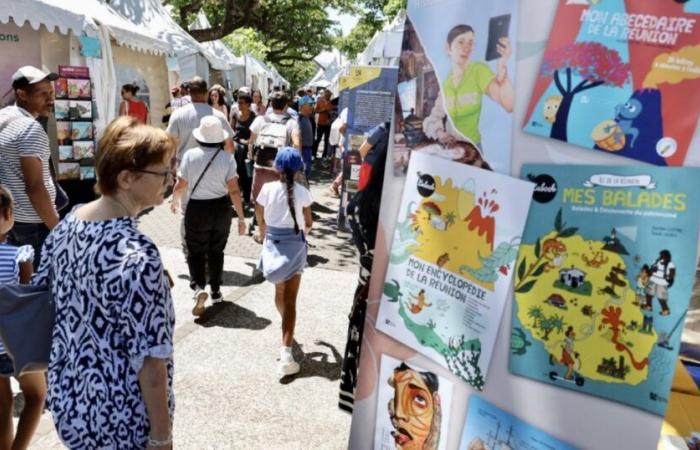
[387,363,442,450]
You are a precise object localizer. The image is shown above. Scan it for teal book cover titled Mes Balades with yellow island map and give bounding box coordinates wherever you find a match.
[510,165,700,415]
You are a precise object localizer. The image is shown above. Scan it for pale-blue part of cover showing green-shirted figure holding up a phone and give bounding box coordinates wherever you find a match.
[410,0,517,173]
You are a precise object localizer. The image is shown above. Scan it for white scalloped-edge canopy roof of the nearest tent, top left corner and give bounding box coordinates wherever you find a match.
[0,0,168,53]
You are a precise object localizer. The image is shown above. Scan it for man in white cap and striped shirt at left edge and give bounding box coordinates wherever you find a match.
[0,66,59,269]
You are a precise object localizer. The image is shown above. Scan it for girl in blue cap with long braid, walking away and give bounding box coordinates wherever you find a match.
[255,147,313,378]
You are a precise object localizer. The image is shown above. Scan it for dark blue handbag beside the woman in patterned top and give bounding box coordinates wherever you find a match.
[0,284,56,377]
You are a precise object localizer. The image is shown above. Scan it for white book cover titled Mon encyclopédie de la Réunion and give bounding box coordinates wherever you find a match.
[377,152,534,390]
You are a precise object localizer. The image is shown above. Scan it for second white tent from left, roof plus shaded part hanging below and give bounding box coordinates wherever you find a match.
[109,0,231,80]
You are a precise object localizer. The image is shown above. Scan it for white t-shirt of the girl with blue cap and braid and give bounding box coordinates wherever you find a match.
[257,181,313,230]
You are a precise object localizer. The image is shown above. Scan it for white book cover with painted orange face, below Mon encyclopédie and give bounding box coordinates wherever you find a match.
[374,354,452,450]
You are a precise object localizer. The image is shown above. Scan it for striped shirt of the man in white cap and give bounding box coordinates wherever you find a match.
[0,105,56,223]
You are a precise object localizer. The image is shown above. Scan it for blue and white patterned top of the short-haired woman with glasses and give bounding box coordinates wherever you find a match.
[32,213,175,449]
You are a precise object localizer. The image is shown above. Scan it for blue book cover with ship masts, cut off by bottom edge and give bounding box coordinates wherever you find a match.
[459,395,576,450]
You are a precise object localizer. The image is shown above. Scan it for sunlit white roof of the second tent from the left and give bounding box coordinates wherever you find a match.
[109,0,230,70]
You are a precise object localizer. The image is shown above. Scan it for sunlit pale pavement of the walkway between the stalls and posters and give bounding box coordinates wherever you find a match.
[19,163,357,450]
